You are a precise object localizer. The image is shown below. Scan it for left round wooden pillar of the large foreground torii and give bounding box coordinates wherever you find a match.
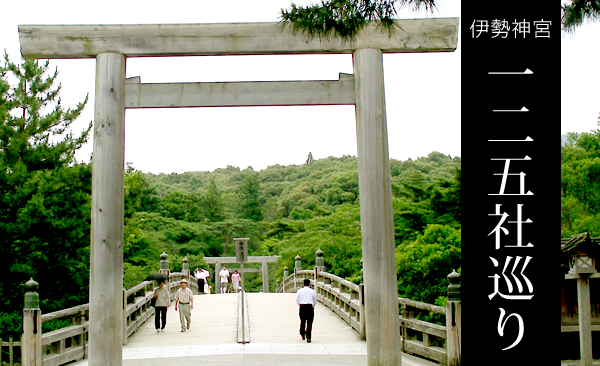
[89,52,125,366]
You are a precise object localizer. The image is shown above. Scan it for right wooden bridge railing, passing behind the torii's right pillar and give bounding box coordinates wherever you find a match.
[279,250,460,365]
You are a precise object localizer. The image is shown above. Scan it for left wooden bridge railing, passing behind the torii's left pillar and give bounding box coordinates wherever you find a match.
[15,253,198,366]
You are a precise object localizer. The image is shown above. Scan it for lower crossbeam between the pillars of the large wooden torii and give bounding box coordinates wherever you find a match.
[125,74,354,108]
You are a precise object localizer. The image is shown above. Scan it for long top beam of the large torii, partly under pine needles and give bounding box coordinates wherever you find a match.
[19,18,458,59]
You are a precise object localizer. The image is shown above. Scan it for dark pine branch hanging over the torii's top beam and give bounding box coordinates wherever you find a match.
[281,0,436,40]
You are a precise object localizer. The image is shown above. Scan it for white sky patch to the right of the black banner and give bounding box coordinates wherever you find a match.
[560,22,600,134]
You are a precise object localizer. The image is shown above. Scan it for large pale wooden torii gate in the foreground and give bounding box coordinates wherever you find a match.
[19,18,458,366]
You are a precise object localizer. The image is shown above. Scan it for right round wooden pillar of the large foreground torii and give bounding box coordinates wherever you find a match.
[352,48,402,366]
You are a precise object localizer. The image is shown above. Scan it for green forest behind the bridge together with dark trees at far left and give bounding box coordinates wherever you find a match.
[0,57,462,338]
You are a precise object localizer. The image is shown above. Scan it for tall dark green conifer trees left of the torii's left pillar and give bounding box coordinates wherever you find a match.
[0,55,92,333]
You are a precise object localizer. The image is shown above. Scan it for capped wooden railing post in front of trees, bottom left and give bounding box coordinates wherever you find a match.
[21,278,42,366]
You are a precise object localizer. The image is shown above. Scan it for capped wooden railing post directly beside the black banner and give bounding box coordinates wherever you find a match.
[446,270,461,366]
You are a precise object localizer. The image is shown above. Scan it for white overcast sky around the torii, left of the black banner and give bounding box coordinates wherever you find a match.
[0,0,462,173]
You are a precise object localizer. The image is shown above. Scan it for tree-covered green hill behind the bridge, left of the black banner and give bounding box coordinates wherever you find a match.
[125,152,461,303]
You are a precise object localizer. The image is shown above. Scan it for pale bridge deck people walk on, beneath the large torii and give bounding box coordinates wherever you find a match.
[74,293,437,366]
